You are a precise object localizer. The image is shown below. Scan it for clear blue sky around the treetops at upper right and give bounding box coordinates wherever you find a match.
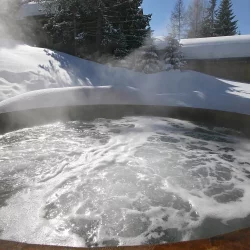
[143,0,250,36]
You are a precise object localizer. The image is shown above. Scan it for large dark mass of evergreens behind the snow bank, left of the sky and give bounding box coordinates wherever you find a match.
[42,0,151,57]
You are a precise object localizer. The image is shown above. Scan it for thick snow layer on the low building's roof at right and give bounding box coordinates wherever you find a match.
[154,35,250,59]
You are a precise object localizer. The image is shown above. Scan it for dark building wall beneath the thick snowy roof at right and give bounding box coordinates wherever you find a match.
[185,57,250,83]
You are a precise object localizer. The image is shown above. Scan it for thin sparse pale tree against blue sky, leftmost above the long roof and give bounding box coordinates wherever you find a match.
[171,0,186,40]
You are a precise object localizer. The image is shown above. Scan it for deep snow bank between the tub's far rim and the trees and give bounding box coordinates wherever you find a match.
[0,41,250,114]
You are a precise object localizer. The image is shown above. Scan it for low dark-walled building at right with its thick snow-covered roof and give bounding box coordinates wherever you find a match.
[155,35,250,83]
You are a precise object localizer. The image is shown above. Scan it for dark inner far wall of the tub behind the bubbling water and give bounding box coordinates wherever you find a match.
[0,105,250,137]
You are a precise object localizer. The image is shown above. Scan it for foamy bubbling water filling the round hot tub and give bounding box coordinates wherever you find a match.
[0,117,250,247]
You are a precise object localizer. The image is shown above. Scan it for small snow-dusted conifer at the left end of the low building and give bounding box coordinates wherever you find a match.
[164,36,185,71]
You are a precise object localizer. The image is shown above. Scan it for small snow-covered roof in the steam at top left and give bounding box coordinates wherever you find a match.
[17,1,45,20]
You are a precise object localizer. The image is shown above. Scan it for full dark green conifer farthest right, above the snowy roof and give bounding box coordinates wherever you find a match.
[215,0,238,36]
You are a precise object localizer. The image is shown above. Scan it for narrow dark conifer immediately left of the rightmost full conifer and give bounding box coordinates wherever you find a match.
[201,0,217,37]
